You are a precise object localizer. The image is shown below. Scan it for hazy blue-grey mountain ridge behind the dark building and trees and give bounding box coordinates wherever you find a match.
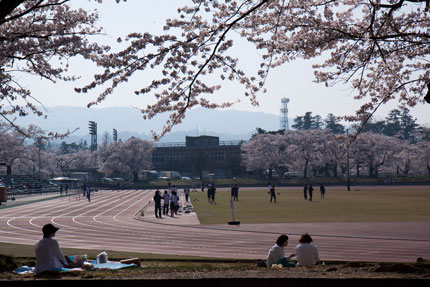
[15,107,292,143]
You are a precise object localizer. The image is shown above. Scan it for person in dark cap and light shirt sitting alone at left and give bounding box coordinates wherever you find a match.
[33,223,67,273]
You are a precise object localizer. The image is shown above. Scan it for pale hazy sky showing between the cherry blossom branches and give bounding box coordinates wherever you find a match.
[16,0,430,126]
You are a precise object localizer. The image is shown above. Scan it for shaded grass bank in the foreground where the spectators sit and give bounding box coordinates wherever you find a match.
[0,243,430,282]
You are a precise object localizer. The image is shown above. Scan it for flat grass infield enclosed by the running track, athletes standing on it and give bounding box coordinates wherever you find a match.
[191,186,430,224]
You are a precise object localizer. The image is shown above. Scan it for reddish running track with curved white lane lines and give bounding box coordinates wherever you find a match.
[0,190,430,262]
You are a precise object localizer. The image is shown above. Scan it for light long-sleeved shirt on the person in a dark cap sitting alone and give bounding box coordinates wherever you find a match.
[33,237,67,273]
